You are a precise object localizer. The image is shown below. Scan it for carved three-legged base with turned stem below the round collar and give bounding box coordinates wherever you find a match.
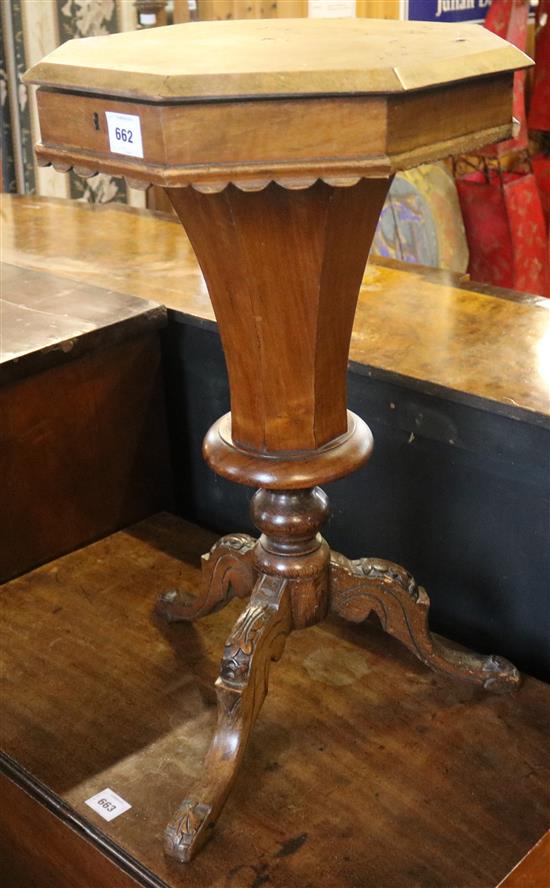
[158,487,520,861]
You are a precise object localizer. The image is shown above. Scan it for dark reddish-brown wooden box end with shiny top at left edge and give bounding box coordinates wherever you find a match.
[0,263,172,582]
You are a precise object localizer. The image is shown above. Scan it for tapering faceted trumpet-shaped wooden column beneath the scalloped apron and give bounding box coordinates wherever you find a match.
[168,179,389,454]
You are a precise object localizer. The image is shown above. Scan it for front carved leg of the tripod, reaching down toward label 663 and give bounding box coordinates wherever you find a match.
[165,575,291,862]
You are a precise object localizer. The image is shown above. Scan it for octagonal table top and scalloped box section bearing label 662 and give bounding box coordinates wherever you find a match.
[25,19,531,191]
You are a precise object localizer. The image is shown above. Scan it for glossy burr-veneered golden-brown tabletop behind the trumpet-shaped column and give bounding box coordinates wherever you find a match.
[2,195,550,423]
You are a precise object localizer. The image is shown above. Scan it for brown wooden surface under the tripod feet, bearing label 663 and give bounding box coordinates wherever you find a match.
[0,514,550,888]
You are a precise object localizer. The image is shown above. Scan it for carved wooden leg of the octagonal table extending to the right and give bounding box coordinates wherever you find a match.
[330,552,521,692]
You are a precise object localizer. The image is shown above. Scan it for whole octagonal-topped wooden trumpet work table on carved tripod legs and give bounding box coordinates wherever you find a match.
[25,19,531,861]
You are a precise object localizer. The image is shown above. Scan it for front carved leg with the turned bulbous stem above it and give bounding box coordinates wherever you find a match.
[165,487,330,861]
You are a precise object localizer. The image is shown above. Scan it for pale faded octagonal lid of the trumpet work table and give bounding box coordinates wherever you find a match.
[25,19,531,102]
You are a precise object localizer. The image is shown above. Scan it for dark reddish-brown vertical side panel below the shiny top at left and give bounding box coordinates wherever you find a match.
[0,330,172,579]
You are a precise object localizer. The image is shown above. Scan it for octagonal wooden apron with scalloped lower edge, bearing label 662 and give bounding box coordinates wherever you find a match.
[36,72,513,192]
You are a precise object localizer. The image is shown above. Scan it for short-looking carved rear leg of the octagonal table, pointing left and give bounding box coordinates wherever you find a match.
[156,533,257,623]
